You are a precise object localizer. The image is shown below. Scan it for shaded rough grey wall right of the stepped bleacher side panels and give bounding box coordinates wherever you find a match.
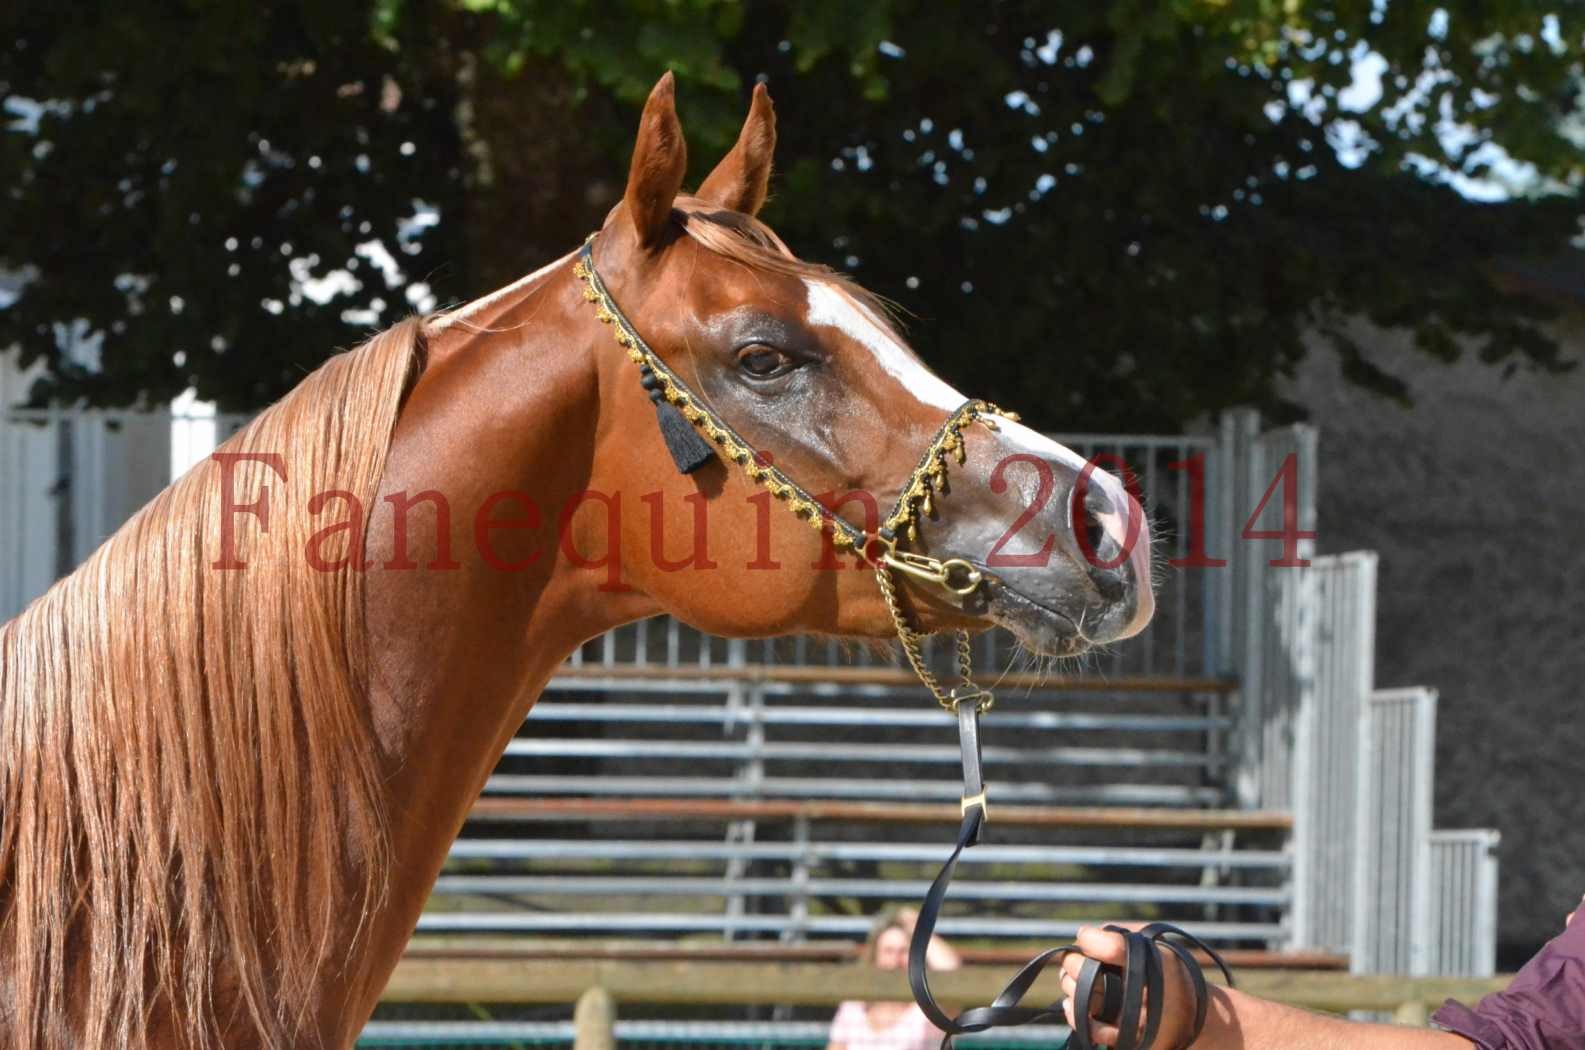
[1290,317,1585,966]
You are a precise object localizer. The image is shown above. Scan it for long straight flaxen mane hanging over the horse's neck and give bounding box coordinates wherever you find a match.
[0,319,425,1050]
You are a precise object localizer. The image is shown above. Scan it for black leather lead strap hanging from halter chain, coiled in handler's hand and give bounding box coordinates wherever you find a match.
[908,699,1233,1050]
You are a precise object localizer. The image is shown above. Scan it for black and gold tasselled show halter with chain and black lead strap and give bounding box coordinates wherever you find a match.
[572,235,1233,1050]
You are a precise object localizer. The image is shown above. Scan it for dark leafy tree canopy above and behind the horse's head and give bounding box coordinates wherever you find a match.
[0,0,1585,428]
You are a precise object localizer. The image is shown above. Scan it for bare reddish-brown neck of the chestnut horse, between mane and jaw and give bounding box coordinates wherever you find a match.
[331,265,656,1034]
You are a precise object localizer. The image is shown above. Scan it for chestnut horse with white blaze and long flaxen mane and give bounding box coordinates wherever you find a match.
[0,75,1152,1050]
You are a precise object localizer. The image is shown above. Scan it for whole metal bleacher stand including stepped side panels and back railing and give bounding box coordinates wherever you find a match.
[415,412,1498,975]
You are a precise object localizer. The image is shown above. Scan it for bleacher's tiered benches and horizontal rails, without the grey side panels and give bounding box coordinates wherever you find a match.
[418,619,1290,952]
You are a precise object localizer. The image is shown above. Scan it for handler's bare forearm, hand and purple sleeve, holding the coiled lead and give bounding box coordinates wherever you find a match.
[1062,901,1585,1050]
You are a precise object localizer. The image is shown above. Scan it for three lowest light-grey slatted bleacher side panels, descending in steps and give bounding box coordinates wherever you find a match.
[1263,564,1498,977]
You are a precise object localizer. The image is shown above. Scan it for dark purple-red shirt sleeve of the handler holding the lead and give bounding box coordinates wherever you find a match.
[1431,917,1585,1050]
